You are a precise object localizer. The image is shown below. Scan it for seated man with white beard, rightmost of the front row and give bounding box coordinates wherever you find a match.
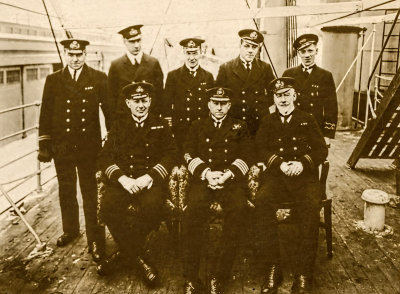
[255,78,328,294]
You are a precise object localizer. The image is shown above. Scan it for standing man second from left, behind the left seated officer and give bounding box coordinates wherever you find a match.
[108,25,164,119]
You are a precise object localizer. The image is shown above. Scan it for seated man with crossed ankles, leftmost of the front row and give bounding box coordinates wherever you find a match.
[98,82,176,285]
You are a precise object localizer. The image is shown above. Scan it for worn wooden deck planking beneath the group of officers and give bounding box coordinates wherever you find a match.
[0,132,400,294]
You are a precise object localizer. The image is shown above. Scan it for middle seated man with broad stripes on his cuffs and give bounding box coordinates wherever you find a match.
[183,88,250,294]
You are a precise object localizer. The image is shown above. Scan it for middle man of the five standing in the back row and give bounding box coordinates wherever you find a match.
[164,38,214,160]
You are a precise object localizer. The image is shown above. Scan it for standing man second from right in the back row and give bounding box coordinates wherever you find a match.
[216,29,274,136]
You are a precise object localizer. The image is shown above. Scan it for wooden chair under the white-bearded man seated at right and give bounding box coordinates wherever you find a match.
[249,160,333,258]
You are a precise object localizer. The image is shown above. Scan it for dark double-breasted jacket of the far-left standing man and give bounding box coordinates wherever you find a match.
[39,64,110,160]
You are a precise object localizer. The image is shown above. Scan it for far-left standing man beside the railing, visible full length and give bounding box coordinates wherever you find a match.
[38,39,110,260]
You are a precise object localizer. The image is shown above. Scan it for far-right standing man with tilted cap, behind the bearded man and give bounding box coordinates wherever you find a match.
[283,34,338,146]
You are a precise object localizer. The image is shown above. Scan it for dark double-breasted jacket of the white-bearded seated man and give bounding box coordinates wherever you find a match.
[256,109,328,190]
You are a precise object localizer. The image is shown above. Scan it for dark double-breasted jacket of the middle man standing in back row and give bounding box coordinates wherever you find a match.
[163,65,214,152]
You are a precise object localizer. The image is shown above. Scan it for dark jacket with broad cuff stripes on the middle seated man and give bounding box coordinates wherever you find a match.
[184,116,251,179]
